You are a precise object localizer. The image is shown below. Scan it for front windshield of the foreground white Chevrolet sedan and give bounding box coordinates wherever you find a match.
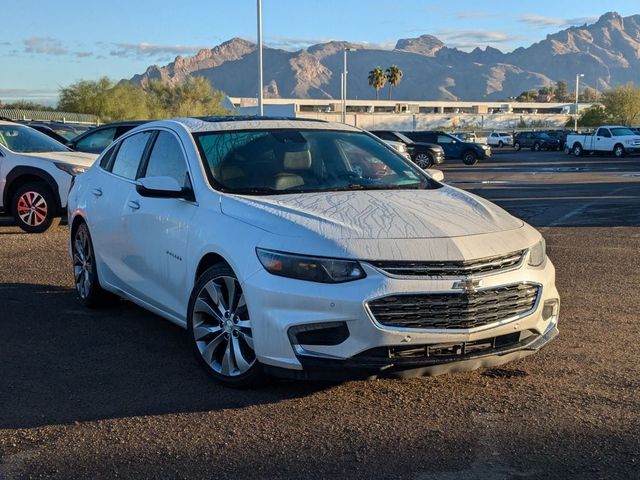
[194,129,437,195]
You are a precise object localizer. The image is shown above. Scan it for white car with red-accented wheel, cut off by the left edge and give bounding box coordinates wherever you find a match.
[0,121,97,233]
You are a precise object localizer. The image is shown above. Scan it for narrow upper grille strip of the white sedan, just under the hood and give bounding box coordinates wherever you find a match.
[368,250,526,277]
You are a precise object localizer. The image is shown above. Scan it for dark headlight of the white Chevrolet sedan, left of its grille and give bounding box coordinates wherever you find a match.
[256,248,366,283]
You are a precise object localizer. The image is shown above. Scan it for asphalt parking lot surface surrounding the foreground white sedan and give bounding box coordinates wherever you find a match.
[0,150,640,480]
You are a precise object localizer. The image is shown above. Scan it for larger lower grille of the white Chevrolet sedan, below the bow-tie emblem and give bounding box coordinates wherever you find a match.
[367,283,540,329]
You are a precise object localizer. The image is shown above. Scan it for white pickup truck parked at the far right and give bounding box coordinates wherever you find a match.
[565,126,640,158]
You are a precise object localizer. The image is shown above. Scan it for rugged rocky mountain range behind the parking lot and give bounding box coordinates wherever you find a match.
[130,12,640,101]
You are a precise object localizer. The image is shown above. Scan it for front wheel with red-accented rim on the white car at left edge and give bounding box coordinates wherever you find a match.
[11,182,60,233]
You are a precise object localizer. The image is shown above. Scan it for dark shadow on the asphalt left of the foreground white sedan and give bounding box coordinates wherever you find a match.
[0,284,331,429]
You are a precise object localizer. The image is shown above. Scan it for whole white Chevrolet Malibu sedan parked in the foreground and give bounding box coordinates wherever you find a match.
[69,117,559,386]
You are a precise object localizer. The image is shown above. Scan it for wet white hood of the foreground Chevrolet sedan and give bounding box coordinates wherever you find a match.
[221,186,523,240]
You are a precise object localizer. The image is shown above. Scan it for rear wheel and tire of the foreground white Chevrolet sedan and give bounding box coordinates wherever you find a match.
[71,222,115,308]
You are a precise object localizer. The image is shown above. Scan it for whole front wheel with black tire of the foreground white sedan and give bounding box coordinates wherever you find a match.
[187,263,267,388]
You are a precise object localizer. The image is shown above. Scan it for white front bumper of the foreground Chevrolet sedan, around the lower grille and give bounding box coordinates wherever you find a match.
[243,260,559,378]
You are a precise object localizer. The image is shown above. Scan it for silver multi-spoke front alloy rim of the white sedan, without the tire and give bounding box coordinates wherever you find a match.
[192,276,256,377]
